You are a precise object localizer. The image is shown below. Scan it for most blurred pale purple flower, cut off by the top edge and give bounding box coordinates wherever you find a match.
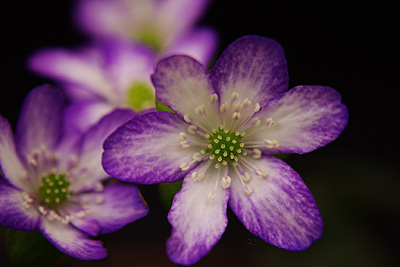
[75,0,217,65]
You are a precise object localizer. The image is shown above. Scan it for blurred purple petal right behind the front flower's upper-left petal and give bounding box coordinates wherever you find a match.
[163,28,218,66]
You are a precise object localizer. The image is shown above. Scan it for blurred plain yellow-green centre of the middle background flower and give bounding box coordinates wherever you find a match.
[126,82,155,112]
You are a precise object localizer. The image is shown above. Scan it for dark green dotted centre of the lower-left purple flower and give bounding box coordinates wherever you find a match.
[39,173,72,206]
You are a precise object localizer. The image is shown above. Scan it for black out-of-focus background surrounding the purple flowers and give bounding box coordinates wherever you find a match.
[0,0,400,266]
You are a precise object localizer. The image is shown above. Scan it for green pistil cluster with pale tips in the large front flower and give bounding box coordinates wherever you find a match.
[204,126,244,167]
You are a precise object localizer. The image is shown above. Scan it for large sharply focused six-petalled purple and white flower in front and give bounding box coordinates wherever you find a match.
[103,36,348,265]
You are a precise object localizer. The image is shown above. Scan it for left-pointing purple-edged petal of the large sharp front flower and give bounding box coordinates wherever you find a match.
[102,111,193,184]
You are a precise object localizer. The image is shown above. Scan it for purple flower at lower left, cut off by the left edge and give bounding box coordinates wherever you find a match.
[0,86,148,260]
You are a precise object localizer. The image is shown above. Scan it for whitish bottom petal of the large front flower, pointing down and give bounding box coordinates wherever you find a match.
[167,166,230,265]
